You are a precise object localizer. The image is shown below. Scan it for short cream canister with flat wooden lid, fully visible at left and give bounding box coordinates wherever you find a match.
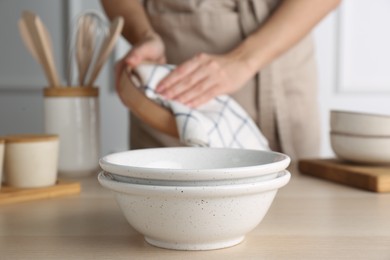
[4,135,59,188]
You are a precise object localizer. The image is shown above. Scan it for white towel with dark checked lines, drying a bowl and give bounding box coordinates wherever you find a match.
[129,64,270,150]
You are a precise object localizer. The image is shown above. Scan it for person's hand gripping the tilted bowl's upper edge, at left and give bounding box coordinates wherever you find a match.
[115,33,166,91]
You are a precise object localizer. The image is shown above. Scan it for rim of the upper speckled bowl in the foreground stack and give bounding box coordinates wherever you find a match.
[99,147,291,180]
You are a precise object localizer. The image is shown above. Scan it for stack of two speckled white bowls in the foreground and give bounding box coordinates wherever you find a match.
[98,147,290,250]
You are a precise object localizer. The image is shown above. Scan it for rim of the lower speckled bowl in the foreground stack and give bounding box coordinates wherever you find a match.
[98,170,291,197]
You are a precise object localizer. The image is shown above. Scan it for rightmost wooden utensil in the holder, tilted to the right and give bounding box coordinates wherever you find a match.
[86,17,124,87]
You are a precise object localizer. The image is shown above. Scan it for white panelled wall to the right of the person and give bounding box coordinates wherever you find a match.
[314,0,390,156]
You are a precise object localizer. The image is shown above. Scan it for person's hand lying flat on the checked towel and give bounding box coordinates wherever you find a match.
[156,53,255,107]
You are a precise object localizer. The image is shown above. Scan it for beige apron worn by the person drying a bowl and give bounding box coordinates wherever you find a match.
[130,0,320,159]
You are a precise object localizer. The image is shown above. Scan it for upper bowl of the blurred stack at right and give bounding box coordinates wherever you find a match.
[330,110,390,137]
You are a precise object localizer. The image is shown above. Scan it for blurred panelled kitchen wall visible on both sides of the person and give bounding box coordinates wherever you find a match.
[0,0,390,156]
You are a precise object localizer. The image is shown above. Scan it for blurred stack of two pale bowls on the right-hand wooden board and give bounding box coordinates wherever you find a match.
[330,110,390,164]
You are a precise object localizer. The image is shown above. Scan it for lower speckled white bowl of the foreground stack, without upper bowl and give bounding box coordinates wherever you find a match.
[98,171,290,250]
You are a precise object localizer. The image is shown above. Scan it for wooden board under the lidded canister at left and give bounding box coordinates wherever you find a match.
[0,180,81,205]
